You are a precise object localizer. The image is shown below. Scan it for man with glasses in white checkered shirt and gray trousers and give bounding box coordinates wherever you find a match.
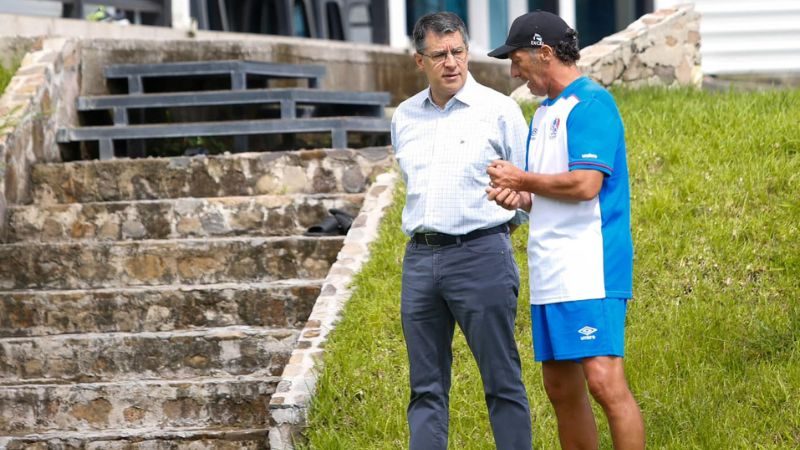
[392,12,531,450]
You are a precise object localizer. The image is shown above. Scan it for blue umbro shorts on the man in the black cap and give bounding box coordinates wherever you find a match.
[531,298,628,361]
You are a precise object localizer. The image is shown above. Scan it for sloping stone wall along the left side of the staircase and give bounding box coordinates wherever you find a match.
[0,38,79,240]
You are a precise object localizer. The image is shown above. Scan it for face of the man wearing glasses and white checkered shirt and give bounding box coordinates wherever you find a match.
[414,31,468,106]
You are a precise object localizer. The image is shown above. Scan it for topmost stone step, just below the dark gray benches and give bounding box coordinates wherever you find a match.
[31,147,393,205]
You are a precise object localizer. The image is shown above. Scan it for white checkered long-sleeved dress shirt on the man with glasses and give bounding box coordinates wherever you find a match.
[392,75,528,236]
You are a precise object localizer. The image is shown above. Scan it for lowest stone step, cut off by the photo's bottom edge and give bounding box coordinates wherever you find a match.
[0,427,269,450]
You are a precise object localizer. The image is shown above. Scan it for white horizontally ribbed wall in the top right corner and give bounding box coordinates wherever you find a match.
[655,0,800,75]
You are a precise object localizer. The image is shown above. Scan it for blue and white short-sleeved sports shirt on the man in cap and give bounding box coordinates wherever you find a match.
[526,77,633,305]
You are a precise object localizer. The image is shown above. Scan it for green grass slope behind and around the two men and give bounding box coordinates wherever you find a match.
[308,86,800,450]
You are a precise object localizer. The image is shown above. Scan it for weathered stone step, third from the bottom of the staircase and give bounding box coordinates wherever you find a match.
[0,326,300,386]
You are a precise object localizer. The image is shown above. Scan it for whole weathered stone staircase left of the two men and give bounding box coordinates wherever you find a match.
[0,147,391,450]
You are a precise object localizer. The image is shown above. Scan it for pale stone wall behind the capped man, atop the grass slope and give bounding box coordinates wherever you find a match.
[511,4,703,101]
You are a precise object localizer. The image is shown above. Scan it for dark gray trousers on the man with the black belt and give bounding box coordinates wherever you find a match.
[401,233,531,450]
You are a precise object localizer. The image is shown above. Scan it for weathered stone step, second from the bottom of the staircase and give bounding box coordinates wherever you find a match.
[0,376,279,436]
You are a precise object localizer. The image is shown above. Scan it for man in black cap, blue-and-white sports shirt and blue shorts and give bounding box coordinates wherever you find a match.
[486,11,645,449]
